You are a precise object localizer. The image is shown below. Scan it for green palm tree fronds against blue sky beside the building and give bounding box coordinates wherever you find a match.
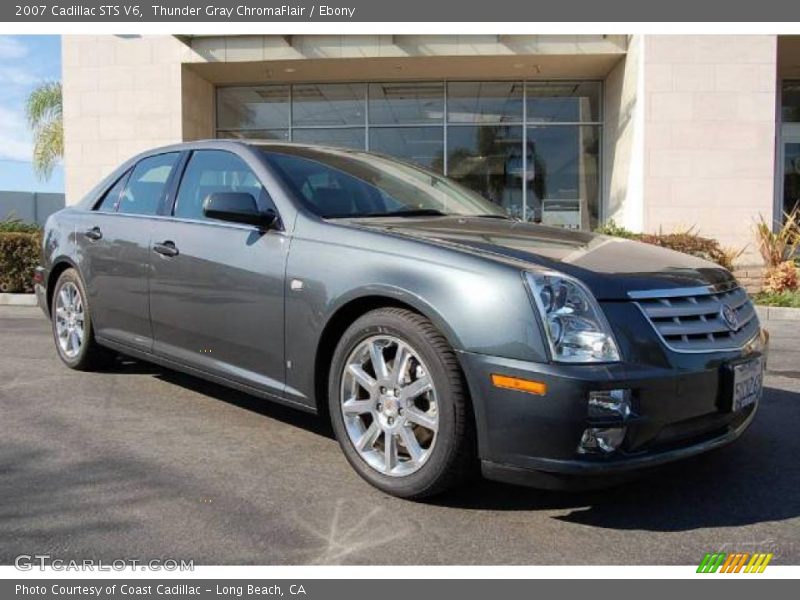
[25,81,64,179]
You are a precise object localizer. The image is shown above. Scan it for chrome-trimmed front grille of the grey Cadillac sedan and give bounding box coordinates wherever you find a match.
[629,282,758,352]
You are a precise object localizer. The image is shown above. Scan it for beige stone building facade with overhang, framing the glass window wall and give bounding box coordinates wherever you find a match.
[62,35,777,273]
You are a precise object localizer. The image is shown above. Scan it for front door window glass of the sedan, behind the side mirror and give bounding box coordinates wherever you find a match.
[174,150,266,219]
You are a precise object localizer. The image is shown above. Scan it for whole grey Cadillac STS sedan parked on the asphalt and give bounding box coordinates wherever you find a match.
[37,141,766,498]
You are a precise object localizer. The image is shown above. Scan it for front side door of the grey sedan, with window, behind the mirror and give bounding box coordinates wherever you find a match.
[150,150,289,396]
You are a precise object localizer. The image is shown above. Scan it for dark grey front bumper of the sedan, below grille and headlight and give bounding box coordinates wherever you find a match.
[459,334,766,489]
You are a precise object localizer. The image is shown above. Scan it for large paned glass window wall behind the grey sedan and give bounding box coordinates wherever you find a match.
[217,81,603,229]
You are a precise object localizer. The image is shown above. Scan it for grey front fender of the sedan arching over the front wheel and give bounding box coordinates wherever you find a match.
[286,220,547,403]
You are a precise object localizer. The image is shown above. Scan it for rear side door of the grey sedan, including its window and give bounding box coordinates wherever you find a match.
[77,152,180,351]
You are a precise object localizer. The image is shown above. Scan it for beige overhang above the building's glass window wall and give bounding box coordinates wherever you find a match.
[179,35,629,85]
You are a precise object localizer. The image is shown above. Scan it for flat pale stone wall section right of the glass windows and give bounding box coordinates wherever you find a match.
[644,35,777,265]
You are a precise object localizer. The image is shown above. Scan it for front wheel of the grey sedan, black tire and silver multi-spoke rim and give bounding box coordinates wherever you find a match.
[328,308,477,499]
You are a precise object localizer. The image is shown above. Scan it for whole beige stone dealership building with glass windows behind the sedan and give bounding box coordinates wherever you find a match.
[62,35,800,265]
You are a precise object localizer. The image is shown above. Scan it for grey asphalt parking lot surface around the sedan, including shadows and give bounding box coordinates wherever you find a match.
[0,307,800,564]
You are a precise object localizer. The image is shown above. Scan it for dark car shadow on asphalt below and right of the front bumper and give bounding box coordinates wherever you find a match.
[435,388,800,531]
